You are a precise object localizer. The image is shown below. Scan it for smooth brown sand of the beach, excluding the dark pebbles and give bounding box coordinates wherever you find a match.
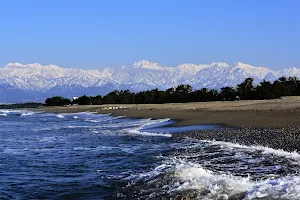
[39,97,300,128]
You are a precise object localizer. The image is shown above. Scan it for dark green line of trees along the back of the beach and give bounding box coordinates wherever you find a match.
[45,77,300,106]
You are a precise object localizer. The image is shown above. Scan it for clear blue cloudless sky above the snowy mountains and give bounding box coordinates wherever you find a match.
[0,0,300,70]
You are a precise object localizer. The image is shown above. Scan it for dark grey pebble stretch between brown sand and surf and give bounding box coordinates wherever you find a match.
[173,126,300,152]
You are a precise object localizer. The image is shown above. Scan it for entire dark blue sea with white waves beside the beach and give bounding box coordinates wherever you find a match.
[0,110,300,200]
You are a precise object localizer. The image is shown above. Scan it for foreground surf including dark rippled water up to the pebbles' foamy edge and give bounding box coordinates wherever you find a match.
[122,140,300,200]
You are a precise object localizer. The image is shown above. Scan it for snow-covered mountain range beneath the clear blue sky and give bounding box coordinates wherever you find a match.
[0,60,300,102]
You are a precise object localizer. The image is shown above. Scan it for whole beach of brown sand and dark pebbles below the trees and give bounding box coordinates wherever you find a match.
[35,97,300,152]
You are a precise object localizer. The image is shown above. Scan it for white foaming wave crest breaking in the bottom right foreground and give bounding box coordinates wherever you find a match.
[131,158,300,200]
